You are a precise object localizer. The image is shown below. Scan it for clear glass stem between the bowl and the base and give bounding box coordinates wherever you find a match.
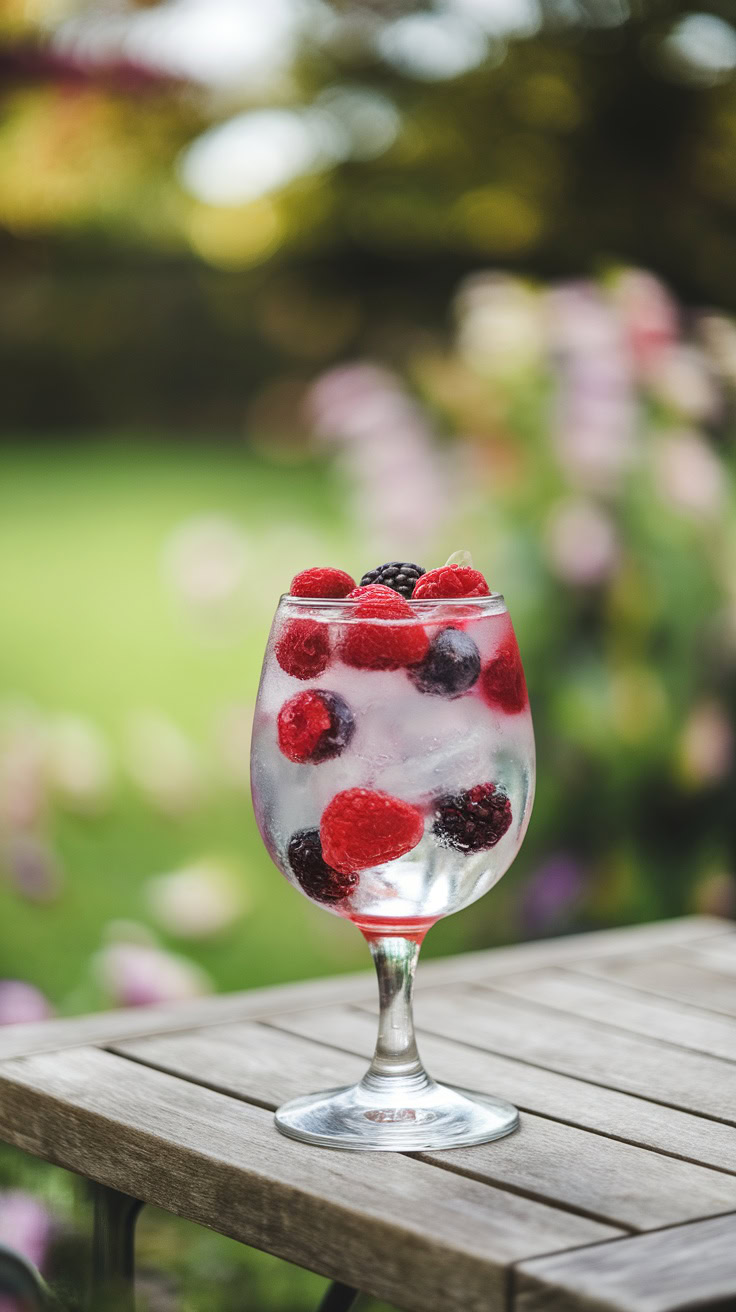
[362,934,430,1090]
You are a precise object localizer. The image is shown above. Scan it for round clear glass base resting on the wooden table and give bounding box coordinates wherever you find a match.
[276,1076,518,1152]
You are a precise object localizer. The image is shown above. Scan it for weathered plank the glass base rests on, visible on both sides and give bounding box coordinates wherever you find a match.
[118,1025,736,1229]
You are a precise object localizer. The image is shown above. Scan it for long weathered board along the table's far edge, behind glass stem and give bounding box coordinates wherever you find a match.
[0,916,732,1061]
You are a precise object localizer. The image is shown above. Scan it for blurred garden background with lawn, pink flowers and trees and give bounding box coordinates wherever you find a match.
[0,0,736,1312]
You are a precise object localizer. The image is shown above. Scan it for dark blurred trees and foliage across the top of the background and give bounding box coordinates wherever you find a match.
[0,0,736,430]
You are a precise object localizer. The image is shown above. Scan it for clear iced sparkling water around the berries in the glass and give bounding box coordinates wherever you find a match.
[252,594,534,934]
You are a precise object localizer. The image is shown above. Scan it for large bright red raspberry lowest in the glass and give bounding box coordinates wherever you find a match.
[320,789,424,874]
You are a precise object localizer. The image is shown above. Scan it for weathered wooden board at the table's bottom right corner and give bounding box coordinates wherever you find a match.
[513,1215,736,1312]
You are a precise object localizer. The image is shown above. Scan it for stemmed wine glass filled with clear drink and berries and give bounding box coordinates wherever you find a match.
[251,593,534,1151]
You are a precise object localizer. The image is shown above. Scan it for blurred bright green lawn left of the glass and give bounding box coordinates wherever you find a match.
[0,442,365,1010]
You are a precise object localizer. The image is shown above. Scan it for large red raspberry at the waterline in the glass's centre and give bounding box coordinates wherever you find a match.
[340,592,429,669]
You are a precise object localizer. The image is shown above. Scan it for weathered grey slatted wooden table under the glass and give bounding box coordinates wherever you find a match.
[0,917,736,1312]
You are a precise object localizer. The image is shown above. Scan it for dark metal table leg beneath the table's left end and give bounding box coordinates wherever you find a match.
[89,1185,143,1312]
